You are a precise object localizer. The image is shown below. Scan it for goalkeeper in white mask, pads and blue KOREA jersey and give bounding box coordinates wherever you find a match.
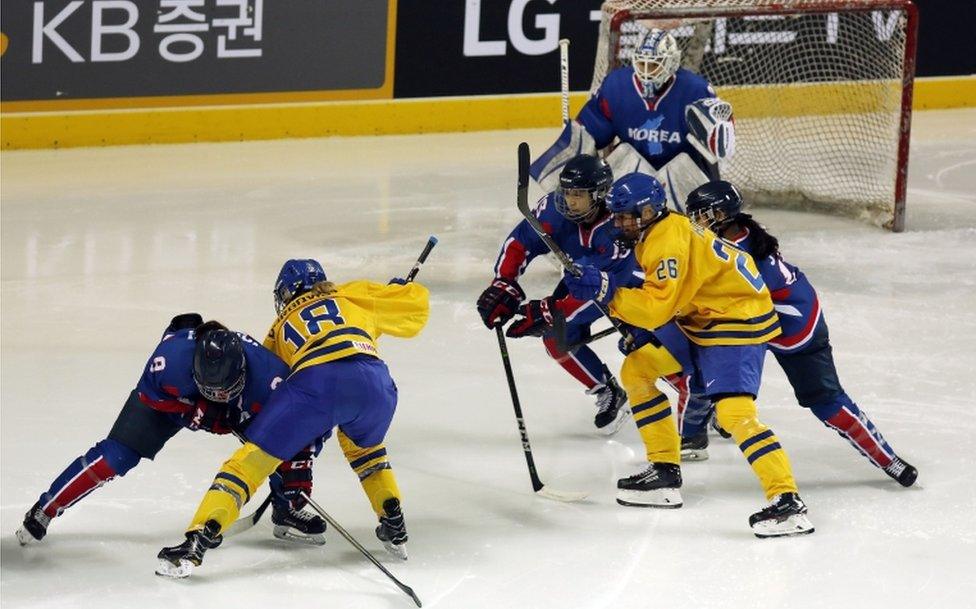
[530,29,735,211]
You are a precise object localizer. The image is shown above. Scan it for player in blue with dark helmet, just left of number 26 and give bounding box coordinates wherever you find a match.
[478,155,633,435]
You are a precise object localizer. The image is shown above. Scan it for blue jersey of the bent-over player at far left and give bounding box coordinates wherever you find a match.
[136,329,289,433]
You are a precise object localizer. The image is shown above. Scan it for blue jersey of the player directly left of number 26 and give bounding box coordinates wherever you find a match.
[495,192,644,323]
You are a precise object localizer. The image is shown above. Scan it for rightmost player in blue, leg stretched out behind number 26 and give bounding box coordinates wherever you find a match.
[682,181,918,486]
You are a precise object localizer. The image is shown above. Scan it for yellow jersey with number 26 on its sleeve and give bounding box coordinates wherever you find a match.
[610,212,780,346]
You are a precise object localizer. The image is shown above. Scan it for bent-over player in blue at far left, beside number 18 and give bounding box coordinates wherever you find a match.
[17,313,326,545]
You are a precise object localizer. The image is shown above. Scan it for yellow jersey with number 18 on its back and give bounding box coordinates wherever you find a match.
[264,281,430,372]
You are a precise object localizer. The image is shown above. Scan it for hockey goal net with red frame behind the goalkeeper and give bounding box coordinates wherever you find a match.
[592,0,917,231]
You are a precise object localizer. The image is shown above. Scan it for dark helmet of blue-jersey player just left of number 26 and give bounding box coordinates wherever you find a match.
[556,154,613,222]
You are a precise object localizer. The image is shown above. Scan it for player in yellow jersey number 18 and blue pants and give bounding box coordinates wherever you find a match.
[156,260,429,577]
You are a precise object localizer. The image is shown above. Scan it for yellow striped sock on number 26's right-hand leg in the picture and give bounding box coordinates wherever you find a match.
[715,396,797,499]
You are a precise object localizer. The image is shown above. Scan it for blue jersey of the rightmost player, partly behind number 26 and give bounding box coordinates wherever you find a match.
[730,228,823,353]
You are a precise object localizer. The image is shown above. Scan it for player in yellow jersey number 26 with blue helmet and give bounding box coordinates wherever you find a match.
[566,173,814,537]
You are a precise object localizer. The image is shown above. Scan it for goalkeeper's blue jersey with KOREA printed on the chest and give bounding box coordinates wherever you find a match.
[576,66,715,169]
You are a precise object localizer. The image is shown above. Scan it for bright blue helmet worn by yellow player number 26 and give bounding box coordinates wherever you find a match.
[607,173,668,248]
